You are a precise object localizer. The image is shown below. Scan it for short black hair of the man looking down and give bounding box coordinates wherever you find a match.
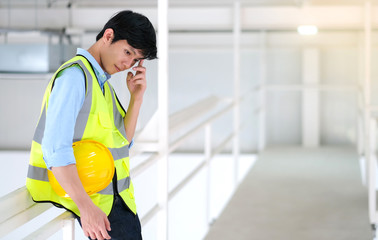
[96,10,157,60]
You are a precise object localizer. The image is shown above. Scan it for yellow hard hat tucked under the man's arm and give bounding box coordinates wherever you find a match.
[47,140,115,198]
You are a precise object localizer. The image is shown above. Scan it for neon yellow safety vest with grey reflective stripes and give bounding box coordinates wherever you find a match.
[26,55,136,216]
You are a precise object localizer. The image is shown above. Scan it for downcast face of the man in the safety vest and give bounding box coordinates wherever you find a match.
[101,40,143,75]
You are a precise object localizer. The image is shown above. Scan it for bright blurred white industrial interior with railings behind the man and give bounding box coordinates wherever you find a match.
[0,0,378,240]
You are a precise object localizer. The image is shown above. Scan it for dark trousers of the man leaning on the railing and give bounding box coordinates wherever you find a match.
[77,194,142,240]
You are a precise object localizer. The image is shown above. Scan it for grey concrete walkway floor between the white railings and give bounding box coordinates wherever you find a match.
[205,147,373,240]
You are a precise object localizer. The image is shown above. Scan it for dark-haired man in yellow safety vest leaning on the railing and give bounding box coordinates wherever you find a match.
[26,11,157,240]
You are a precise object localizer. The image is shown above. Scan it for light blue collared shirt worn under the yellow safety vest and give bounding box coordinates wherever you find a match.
[42,48,133,169]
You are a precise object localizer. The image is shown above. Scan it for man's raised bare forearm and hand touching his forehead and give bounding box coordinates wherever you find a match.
[124,60,147,141]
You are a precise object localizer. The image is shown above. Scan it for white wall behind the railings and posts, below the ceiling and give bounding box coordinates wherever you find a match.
[0,32,364,152]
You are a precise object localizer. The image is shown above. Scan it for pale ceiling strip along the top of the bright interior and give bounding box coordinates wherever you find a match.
[0,0,378,32]
